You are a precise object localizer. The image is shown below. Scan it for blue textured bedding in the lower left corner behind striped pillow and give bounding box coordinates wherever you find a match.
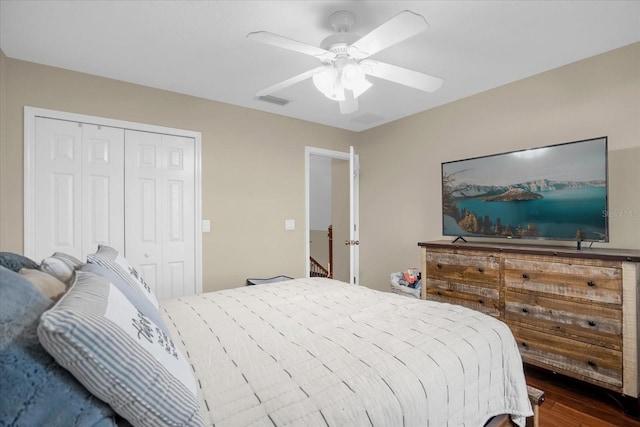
[0,266,115,427]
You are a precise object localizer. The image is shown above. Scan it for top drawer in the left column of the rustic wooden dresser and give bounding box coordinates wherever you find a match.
[426,253,500,289]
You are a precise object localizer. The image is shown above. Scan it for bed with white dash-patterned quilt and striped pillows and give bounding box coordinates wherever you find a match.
[0,248,533,427]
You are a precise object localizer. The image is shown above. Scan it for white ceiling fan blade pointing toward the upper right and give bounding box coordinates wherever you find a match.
[350,10,429,58]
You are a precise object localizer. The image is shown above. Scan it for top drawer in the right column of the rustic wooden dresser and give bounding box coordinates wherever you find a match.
[504,258,622,306]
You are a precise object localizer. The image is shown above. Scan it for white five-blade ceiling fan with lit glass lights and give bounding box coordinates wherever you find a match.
[247,10,442,114]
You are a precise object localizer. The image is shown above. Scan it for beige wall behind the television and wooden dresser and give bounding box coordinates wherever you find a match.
[356,43,640,290]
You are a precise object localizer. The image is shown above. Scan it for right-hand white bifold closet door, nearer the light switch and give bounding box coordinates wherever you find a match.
[125,130,196,300]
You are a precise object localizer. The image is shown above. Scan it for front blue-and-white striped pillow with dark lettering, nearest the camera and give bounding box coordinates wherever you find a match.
[38,271,203,427]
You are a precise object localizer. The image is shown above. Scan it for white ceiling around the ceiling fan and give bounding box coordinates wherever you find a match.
[0,0,640,131]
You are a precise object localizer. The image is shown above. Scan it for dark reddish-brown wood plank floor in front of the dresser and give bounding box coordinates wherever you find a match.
[525,366,640,427]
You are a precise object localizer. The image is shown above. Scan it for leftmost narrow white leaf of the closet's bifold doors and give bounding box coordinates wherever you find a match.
[31,117,82,262]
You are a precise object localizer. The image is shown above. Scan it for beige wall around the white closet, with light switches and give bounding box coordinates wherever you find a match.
[0,51,353,290]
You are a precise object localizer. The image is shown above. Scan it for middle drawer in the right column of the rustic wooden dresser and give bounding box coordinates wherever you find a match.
[505,289,622,350]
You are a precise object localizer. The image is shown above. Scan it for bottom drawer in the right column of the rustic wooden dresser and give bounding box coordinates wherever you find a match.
[510,325,622,391]
